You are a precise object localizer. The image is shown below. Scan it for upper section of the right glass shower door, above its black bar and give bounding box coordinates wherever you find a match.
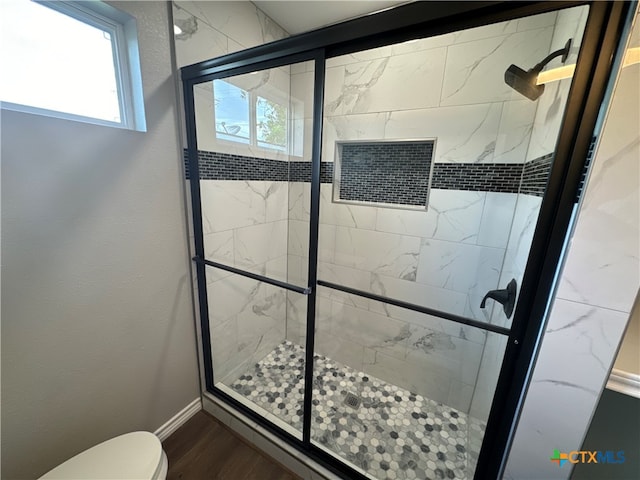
[319,6,589,334]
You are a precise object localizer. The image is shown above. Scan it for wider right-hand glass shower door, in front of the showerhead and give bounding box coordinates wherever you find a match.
[311,7,588,479]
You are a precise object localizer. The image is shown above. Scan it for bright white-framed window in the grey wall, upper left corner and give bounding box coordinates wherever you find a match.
[0,0,145,131]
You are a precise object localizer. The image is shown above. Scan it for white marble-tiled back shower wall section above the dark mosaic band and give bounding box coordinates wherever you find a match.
[292,13,556,163]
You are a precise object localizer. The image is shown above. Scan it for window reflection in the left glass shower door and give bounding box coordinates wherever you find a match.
[213,80,289,151]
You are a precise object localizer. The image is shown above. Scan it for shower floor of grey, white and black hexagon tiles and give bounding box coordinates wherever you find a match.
[221,341,485,479]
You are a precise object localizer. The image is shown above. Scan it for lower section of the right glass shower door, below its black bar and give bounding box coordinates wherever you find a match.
[311,287,506,479]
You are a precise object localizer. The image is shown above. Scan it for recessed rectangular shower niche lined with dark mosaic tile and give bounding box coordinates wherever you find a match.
[337,141,434,207]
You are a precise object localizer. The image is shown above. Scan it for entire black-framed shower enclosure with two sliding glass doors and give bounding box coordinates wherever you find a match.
[182,2,626,479]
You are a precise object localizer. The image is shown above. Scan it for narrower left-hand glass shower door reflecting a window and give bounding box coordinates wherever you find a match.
[193,62,313,438]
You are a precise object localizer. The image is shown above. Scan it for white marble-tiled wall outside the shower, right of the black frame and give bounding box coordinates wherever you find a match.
[506,5,640,480]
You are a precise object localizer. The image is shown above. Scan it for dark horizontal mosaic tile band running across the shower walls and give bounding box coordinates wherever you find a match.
[183,149,553,197]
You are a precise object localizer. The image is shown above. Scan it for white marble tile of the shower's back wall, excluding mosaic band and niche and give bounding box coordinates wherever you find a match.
[287,13,580,416]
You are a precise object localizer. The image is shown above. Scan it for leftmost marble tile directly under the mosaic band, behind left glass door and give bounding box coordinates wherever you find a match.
[200,180,266,234]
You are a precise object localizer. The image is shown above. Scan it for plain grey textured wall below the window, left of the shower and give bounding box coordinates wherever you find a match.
[2,2,199,479]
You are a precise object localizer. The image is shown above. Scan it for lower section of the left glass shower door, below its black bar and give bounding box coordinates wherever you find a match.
[207,267,307,438]
